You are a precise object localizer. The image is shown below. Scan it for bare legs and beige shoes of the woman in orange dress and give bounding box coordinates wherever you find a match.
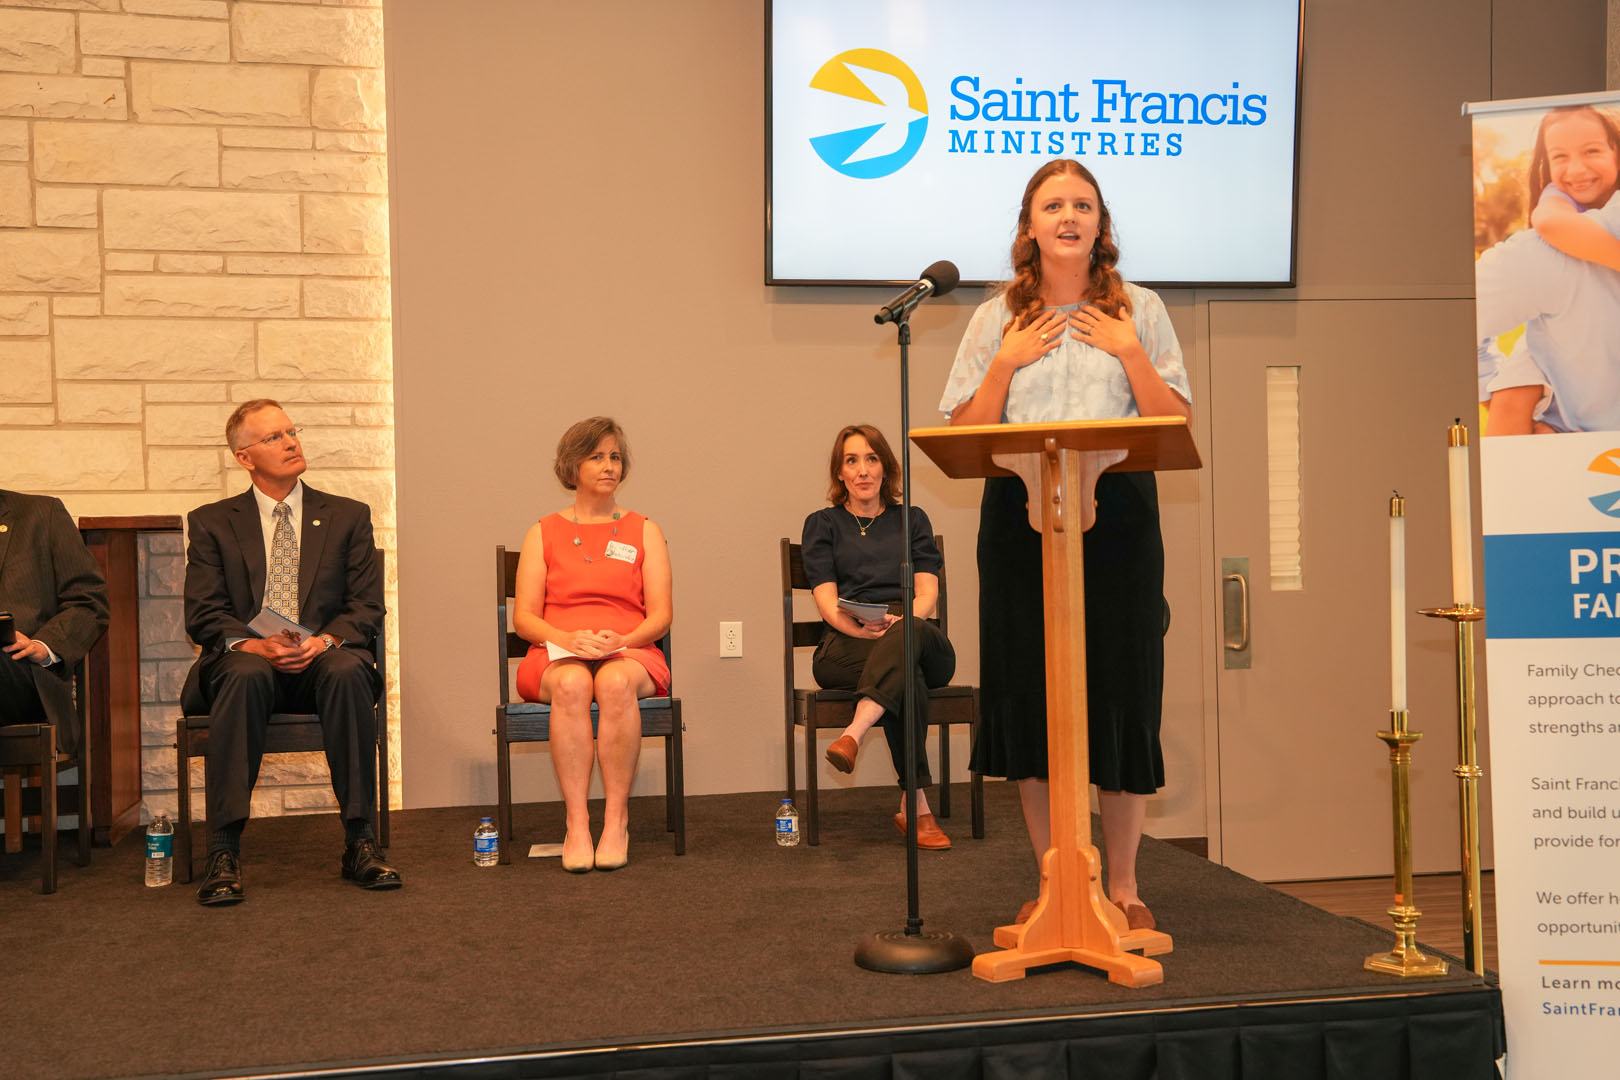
[539,659,653,871]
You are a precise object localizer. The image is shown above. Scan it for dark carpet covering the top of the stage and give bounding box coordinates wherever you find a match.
[0,784,1481,1077]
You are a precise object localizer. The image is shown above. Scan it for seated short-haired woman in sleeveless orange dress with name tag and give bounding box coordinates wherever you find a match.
[512,416,672,874]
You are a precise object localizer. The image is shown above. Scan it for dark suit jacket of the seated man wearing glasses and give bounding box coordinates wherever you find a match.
[180,484,384,716]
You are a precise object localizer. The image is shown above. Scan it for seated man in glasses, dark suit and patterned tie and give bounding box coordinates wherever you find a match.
[181,398,400,905]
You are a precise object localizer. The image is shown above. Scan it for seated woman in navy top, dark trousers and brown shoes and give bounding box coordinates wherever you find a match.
[802,424,956,850]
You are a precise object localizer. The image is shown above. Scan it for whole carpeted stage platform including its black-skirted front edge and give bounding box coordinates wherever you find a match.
[0,782,1503,1080]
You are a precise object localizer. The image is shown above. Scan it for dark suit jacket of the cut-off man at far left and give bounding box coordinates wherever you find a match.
[0,489,107,750]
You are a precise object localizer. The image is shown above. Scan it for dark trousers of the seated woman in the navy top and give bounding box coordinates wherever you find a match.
[810,619,956,789]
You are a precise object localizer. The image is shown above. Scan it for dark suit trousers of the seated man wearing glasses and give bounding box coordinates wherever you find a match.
[203,649,381,829]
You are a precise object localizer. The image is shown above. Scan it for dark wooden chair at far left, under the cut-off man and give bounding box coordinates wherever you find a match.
[0,661,92,894]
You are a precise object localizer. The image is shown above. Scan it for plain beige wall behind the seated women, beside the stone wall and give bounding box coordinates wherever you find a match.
[385,2,1204,836]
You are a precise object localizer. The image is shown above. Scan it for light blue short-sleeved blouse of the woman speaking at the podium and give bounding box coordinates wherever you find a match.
[940,282,1192,424]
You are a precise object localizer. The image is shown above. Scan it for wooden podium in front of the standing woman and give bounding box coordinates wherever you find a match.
[910,416,1202,986]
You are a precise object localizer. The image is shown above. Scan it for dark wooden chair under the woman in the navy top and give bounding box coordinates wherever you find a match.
[782,536,985,844]
